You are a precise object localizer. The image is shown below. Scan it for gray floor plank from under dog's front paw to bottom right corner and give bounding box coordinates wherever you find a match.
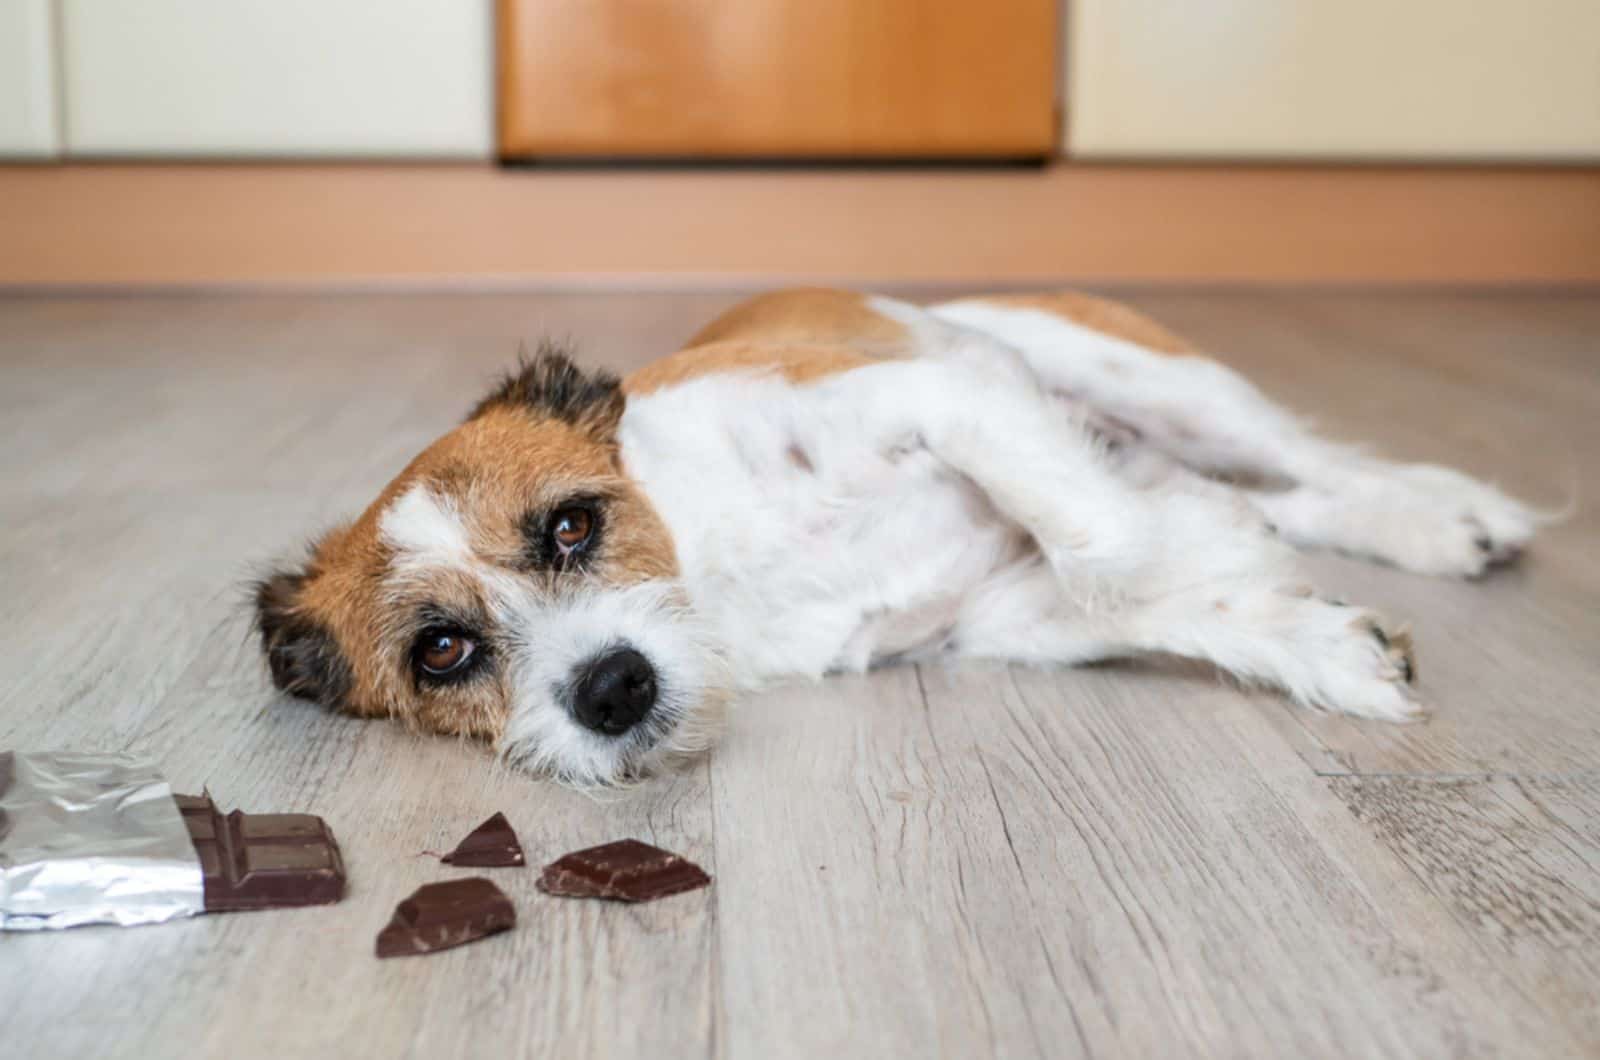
[926,668,1594,1055]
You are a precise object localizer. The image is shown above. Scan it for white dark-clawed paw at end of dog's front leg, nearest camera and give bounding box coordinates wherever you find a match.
[1285,600,1427,722]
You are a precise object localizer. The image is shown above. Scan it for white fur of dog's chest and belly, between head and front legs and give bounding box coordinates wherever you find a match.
[621,373,1024,687]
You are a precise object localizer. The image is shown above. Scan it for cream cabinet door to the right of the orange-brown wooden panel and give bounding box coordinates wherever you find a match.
[1066,0,1600,160]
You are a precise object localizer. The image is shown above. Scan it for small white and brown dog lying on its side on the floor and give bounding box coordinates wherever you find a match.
[256,290,1536,785]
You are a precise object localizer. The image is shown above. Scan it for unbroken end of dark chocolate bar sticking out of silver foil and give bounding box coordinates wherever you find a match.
[173,796,344,913]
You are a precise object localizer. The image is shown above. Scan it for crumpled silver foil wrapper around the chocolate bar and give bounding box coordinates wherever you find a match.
[0,751,205,930]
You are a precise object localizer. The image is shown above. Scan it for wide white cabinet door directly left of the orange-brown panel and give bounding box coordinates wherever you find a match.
[60,0,493,157]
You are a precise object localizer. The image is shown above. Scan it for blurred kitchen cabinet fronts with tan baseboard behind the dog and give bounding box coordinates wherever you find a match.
[0,0,1600,287]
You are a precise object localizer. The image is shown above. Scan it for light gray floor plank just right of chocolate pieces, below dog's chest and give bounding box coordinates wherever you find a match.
[712,668,1098,1057]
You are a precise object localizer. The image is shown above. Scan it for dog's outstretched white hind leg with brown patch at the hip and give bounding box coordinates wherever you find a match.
[931,296,1539,576]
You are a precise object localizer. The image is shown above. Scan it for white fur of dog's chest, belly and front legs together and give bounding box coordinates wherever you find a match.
[621,315,1418,719]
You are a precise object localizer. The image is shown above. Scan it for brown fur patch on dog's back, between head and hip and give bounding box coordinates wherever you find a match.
[685,287,914,357]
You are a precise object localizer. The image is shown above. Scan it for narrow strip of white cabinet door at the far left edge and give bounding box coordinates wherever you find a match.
[0,0,59,159]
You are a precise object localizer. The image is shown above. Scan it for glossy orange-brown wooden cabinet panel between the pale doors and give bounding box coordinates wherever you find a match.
[499,0,1058,157]
